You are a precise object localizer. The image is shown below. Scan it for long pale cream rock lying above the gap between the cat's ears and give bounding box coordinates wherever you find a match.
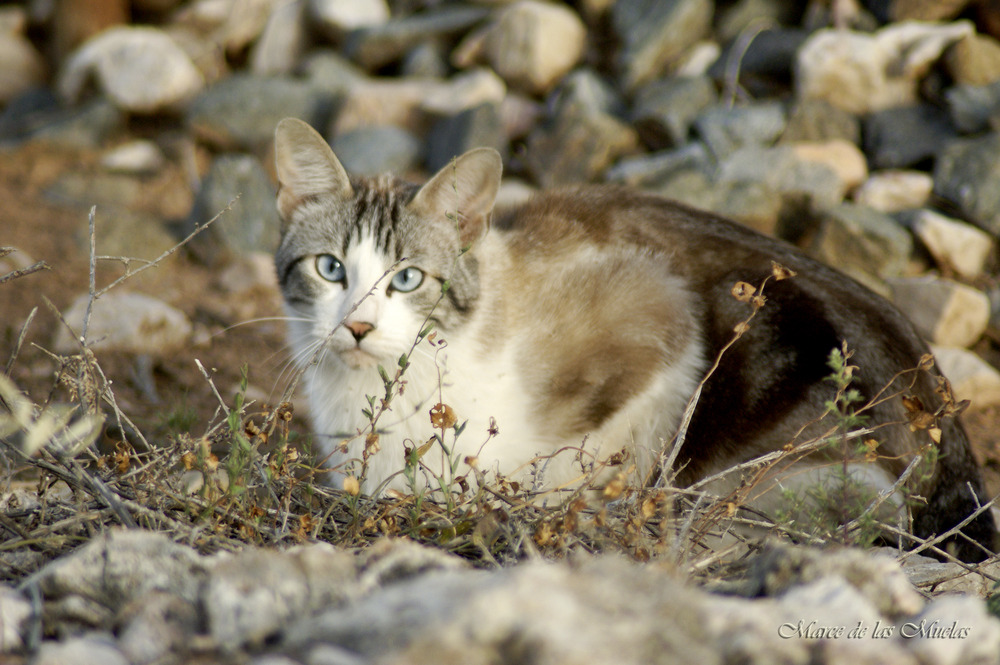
[334,69,506,136]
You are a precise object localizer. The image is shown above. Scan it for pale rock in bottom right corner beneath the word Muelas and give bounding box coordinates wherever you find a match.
[899,596,1000,665]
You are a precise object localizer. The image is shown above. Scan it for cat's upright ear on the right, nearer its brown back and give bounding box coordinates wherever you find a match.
[409,148,503,247]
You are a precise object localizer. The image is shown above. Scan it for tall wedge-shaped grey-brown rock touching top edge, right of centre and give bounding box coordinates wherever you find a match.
[611,0,714,91]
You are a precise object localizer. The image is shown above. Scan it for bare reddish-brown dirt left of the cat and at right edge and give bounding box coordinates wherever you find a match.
[0,139,1000,495]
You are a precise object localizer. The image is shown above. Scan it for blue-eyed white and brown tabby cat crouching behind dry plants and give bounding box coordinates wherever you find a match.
[275,118,996,560]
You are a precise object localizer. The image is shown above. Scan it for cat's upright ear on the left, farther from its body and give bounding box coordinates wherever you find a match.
[274,118,352,222]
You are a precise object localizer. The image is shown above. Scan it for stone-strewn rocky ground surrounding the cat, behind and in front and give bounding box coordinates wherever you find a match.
[0,0,1000,663]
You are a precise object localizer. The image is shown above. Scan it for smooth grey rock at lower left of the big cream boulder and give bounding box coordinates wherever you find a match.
[694,102,785,161]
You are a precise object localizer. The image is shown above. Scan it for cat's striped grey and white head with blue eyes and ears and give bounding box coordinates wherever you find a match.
[275,118,502,368]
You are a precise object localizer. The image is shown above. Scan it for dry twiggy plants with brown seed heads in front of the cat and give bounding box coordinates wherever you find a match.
[0,205,989,600]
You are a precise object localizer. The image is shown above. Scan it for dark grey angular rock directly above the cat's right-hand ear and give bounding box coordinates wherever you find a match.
[426,104,507,173]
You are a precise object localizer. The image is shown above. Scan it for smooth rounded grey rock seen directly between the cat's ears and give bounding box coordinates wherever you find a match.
[333,125,423,175]
